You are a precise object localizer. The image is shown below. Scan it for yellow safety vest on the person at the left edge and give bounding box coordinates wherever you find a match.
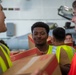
[0,44,12,72]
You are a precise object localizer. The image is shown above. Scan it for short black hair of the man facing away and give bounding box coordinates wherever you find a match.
[53,27,65,41]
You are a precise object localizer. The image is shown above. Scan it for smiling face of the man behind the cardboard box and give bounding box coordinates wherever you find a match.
[32,27,48,46]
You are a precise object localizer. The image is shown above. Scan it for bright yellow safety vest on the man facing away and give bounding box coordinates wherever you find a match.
[47,45,74,63]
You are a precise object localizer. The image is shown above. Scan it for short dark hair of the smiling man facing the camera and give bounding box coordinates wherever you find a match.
[31,22,49,34]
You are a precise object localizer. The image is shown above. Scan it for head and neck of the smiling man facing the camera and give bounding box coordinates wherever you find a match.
[31,22,49,54]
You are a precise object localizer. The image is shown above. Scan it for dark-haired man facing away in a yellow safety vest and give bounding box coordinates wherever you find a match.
[47,27,74,75]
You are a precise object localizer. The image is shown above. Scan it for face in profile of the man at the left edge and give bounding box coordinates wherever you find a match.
[0,5,7,33]
